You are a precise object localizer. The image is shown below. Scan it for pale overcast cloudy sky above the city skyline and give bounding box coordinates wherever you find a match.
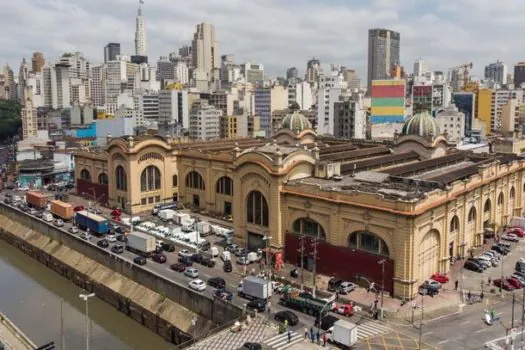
[0,0,525,77]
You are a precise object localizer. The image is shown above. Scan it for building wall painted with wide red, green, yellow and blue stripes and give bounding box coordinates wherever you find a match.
[370,80,406,124]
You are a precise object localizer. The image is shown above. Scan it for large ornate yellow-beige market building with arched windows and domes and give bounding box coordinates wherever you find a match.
[75,113,525,297]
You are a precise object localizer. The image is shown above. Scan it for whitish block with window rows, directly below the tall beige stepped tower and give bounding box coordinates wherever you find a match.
[190,99,222,141]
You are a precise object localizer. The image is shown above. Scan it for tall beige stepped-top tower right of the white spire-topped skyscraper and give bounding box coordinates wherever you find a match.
[191,23,220,80]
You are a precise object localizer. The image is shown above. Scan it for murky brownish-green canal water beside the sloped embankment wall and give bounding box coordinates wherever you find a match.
[0,240,174,350]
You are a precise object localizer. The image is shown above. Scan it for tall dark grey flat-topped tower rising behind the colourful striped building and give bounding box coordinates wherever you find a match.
[367,28,401,94]
